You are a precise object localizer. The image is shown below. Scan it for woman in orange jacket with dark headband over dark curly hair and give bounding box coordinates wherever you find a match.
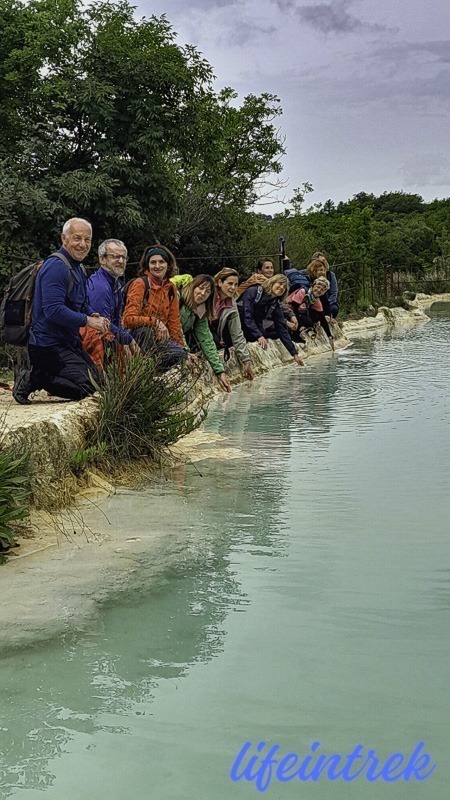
[122,244,187,369]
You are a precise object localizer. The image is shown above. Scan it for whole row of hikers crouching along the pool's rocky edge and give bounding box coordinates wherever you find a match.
[13,218,338,404]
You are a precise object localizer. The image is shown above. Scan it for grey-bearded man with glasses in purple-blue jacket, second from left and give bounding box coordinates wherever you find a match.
[85,239,139,362]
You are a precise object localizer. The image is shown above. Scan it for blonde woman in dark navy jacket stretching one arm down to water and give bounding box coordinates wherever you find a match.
[238,275,303,366]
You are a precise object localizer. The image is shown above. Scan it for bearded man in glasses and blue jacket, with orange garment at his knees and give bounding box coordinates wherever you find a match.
[83,239,139,369]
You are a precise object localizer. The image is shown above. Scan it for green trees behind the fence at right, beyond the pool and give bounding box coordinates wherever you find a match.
[243,191,450,311]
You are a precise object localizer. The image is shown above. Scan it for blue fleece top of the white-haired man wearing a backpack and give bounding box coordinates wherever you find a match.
[29,247,93,347]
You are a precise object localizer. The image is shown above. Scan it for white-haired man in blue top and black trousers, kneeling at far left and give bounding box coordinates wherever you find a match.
[13,217,109,405]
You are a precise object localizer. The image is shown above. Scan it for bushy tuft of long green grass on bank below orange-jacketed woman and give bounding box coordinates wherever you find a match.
[89,349,205,466]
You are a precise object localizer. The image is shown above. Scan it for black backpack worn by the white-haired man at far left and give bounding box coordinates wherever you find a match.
[0,253,73,347]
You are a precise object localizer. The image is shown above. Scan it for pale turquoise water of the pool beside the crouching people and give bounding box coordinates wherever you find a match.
[0,307,450,800]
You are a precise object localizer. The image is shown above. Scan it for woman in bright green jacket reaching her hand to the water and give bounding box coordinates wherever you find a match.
[172,275,231,392]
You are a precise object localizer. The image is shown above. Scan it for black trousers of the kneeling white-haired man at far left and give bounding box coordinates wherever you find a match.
[28,343,100,400]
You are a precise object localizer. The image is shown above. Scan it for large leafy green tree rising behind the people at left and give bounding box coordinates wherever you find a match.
[0,0,283,282]
